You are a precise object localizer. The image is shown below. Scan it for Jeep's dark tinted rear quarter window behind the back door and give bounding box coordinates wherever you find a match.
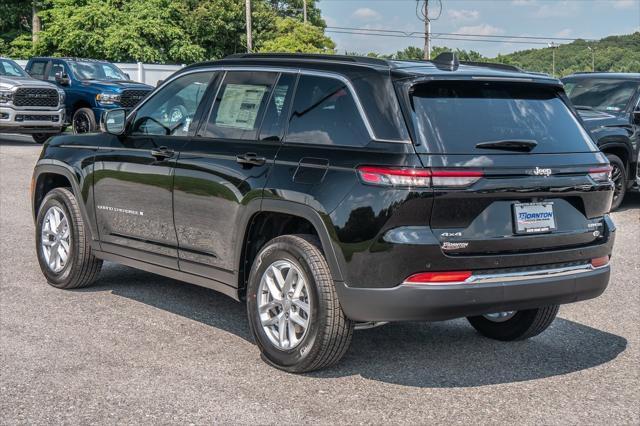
[286,75,370,146]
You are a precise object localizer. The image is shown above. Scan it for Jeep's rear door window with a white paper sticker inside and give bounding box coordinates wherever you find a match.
[206,71,278,140]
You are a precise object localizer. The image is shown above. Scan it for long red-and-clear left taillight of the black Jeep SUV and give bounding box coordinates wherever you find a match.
[358,166,483,188]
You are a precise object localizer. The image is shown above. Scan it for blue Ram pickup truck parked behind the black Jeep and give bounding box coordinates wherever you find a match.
[26,58,153,133]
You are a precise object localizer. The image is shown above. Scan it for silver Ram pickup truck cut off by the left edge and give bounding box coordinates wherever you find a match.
[0,58,65,143]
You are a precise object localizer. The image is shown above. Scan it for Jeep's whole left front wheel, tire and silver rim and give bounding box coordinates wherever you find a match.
[36,188,102,289]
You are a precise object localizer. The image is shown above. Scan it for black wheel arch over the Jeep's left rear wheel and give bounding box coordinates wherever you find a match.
[236,200,343,298]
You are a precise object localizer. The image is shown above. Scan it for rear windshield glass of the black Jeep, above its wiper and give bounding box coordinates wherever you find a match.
[411,81,596,154]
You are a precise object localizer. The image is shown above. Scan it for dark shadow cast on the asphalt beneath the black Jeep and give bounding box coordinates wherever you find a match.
[84,263,627,388]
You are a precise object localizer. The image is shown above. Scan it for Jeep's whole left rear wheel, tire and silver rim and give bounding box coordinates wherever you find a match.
[247,235,353,373]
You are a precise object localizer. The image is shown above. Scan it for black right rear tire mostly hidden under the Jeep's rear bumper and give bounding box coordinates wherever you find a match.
[467,305,559,341]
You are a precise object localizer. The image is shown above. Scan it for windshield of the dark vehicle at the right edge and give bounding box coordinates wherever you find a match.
[565,78,640,112]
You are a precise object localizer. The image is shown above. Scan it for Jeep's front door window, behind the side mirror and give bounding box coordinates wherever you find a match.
[132,72,214,136]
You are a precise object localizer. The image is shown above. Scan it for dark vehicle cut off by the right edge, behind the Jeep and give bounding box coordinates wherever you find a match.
[562,73,640,210]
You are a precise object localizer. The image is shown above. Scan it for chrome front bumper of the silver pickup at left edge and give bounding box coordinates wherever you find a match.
[0,107,65,133]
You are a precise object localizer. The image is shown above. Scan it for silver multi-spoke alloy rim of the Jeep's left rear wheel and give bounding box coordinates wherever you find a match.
[257,260,311,350]
